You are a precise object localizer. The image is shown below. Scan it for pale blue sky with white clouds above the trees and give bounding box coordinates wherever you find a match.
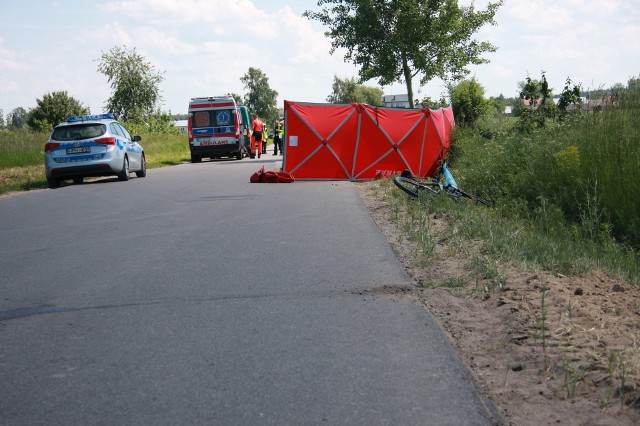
[0,0,640,117]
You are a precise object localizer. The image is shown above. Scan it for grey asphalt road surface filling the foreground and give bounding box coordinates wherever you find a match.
[0,154,495,425]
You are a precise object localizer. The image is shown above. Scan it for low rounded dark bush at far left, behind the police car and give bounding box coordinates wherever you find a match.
[27,90,90,132]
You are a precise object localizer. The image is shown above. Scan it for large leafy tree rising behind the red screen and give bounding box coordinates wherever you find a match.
[303,0,502,106]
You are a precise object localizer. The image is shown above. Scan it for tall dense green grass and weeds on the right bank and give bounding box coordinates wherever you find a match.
[452,96,640,248]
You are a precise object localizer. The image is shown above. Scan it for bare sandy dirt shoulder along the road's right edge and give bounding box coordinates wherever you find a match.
[355,181,640,426]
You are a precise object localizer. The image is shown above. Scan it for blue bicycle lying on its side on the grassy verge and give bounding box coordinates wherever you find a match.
[392,160,490,206]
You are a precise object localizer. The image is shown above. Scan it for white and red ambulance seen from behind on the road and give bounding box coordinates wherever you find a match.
[188,95,250,163]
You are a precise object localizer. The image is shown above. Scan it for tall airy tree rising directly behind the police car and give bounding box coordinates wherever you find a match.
[98,46,164,122]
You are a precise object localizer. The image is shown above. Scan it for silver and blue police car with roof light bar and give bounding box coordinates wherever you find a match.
[44,114,147,188]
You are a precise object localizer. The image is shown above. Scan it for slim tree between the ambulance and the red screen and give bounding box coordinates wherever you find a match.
[240,67,278,123]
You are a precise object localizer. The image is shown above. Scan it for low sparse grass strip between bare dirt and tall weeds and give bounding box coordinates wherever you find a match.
[381,175,640,284]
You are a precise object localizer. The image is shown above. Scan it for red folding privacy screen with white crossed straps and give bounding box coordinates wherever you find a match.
[283,101,454,180]
